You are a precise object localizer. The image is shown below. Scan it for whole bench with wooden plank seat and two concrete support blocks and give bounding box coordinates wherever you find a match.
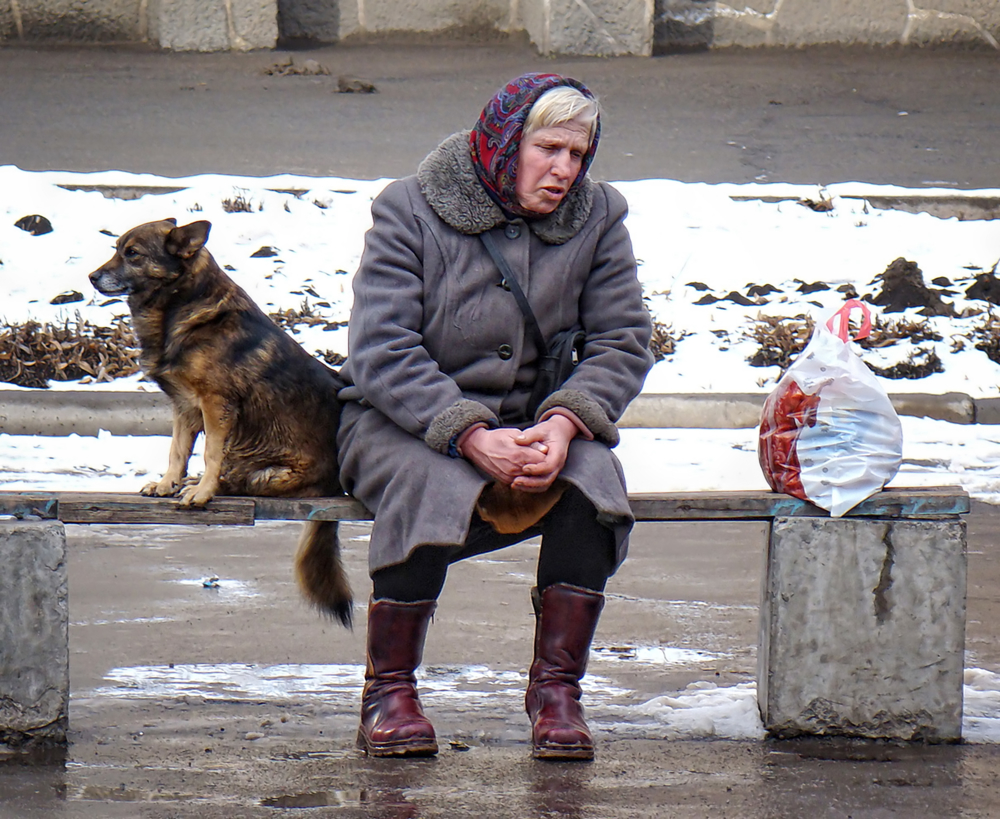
[0,487,969,746]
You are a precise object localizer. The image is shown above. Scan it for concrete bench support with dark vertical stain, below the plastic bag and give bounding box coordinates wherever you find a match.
[757,518,966,742]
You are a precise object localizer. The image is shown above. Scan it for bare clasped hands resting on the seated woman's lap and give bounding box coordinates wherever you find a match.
[462,415,577,492]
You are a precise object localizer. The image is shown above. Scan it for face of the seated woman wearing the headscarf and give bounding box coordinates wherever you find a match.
[514,120,590,213]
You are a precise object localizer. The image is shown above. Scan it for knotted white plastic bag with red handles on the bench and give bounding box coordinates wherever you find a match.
[757,299,903,517]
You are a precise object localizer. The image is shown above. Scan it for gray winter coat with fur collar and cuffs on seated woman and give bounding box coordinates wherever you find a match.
[338,132,652,572]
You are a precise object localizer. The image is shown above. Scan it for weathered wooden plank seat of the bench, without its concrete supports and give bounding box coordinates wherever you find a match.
[0,487,970,526]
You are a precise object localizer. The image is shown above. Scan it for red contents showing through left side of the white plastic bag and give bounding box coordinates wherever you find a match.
[757,381,819,500]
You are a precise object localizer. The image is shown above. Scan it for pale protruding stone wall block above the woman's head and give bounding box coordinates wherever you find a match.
[521,0,654,57]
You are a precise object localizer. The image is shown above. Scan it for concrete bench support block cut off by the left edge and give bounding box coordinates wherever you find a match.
[0,521,69,747]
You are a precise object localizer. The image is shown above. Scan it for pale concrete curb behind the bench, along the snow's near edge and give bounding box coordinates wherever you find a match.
[0,390,1000,436]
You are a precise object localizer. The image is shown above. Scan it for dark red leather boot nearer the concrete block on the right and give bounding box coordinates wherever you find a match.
[524,583,604,759]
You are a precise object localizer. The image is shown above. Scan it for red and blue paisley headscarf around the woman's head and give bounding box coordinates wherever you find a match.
[469,74,601,216]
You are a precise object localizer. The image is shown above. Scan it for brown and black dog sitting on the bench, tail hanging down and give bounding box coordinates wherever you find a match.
[90,219,351,626]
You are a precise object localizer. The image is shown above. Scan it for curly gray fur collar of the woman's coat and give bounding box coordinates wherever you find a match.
[417,131,595,245]
